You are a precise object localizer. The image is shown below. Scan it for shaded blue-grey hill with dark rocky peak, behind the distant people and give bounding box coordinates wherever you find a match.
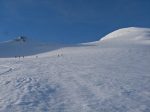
[0,37,63,58]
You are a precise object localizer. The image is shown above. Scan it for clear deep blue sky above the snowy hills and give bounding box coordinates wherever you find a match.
[0,0,150,43]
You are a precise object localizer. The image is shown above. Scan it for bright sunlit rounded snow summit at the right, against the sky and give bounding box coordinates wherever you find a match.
[100,27,150,42]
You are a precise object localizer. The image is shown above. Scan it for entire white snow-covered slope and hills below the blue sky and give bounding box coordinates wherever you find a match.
[0,28,150,112]
